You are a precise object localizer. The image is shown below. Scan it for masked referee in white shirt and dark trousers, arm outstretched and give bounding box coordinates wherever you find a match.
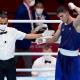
[0,10,42,80]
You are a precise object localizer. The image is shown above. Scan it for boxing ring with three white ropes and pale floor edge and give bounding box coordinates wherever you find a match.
[5,20,61,80]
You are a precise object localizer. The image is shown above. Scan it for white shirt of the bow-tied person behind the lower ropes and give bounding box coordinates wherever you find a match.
[31,56,56,77]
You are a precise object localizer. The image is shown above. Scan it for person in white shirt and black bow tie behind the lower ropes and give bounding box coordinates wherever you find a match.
[31,45,56,77]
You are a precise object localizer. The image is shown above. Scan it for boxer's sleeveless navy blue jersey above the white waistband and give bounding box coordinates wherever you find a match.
[60,23,80,50]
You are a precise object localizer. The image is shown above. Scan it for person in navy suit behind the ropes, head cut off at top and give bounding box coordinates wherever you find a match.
[14,0,35,75]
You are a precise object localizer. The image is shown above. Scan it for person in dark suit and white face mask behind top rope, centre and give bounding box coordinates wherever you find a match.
[32,1,52,33]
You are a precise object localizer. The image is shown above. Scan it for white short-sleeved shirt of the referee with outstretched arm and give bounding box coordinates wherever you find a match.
[0,27,26,60]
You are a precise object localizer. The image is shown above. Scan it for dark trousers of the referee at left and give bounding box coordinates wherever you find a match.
[0,58,16,80]
